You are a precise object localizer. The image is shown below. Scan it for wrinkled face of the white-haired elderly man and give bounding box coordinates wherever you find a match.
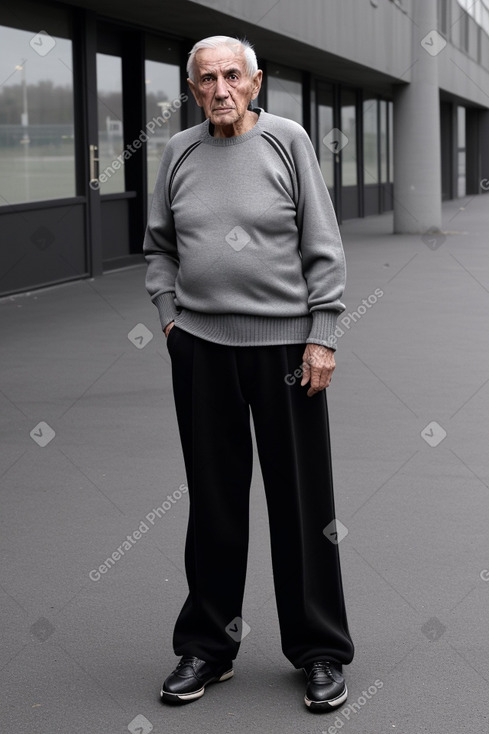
[188,44,262,129]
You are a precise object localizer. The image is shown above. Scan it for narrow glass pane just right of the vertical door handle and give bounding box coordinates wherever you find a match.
[97,53,125,194]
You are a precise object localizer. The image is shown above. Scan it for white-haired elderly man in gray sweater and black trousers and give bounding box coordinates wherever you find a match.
[144,36,353,711]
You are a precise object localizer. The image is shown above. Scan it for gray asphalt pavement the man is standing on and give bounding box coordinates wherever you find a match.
[0,195,489,734]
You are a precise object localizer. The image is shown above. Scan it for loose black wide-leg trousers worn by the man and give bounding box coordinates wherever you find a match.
[168,327,353,668]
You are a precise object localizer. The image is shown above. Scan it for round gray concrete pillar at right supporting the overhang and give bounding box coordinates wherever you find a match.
[394,0,444,234]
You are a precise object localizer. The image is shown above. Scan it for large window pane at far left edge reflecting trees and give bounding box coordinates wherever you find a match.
[0,26,75,206]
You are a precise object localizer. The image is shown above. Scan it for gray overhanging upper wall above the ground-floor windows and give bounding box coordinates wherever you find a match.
[61,0,489,108]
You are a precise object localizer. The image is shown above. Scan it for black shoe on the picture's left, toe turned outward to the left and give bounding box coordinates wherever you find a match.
[160,656,234,703]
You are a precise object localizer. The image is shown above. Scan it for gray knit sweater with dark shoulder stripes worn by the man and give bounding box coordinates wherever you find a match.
[144,108,345,348]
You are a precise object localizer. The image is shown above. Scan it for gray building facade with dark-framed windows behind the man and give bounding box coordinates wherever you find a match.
[0,0,489,295]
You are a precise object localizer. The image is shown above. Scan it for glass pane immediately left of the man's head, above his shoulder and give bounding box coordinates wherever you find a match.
[145,61,181,200]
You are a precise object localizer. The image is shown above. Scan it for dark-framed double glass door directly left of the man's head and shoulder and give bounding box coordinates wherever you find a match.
[90,28,187,270]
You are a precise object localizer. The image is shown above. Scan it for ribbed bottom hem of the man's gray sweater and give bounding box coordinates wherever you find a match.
[175,310,312,347]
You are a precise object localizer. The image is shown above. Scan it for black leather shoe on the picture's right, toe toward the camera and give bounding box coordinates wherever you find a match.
[304,660,348,711]
